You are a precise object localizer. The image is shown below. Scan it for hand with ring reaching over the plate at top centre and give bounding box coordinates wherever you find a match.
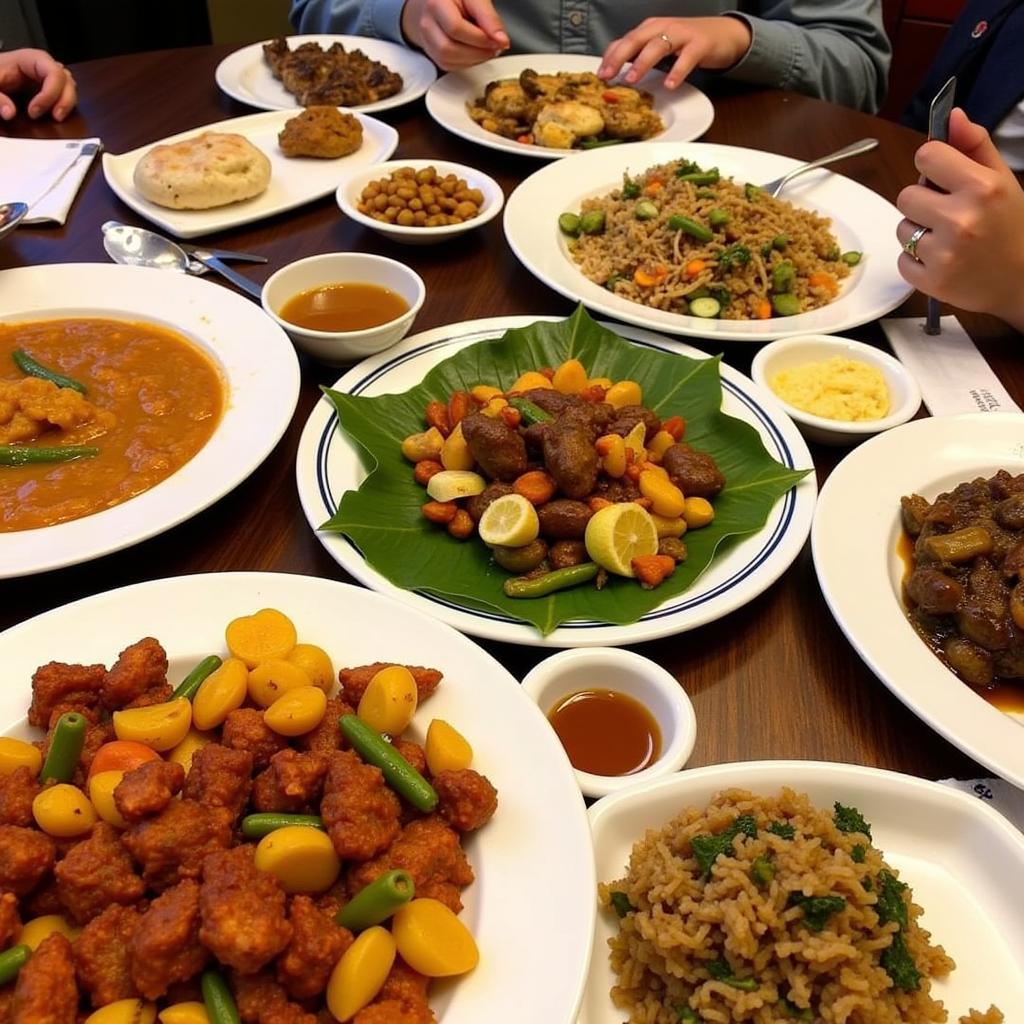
[597,17,752,89]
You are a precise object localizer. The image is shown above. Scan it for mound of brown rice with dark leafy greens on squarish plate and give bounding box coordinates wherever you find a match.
[599,788,1004,1024]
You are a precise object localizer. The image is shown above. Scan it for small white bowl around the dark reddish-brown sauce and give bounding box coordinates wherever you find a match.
[522,647,697,797]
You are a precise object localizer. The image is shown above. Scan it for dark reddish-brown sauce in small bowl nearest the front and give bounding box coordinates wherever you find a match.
[548,688,662,776]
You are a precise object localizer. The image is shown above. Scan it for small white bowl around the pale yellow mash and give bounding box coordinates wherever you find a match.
[751,334,921,444]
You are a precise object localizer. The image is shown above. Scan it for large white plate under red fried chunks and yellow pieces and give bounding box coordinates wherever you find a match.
[0,572,595,1024]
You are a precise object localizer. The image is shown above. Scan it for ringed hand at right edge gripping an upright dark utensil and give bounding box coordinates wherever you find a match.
[896,109,1024,331]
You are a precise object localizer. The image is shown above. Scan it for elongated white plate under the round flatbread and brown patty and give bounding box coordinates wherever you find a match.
[103,111,398,239]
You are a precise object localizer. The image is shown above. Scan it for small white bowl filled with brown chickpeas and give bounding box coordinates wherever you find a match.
[336,160,505,245]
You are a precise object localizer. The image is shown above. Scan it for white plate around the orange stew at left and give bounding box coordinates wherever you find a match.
[0,263,299,579]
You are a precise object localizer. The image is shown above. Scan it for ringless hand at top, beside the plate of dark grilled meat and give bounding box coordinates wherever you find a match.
[401,0,509,71]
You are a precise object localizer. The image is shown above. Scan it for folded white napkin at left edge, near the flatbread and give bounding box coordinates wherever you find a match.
[0,138,101,224]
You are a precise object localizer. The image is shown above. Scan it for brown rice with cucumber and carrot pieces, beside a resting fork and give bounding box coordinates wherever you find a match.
[559,160,861,321]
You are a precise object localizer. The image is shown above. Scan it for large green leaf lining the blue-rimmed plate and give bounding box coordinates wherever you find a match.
[321,306,810,634]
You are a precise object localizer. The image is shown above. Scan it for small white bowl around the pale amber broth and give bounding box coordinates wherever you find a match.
[261,253,427,367]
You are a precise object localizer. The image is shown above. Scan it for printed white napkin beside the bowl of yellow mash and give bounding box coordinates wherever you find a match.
[882,316,1021,416]
